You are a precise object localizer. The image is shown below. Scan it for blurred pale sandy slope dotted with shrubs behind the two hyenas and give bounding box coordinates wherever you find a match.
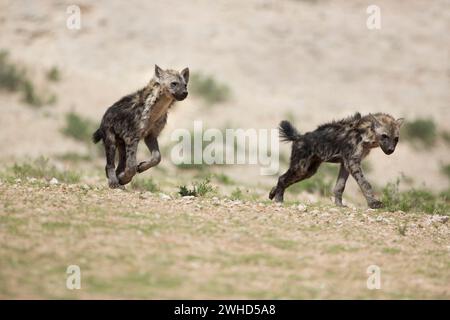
[0,0,450,205]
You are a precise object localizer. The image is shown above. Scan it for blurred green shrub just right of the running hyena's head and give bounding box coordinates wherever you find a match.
[190,73,231,105]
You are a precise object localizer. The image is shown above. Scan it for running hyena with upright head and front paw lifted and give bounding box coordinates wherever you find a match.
[92,66,189,188]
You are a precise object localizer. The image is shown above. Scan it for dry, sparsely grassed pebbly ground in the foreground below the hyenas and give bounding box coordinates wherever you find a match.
[0,182,450,299]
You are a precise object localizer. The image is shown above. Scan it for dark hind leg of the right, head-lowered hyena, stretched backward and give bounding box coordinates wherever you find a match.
[269,159,322,202]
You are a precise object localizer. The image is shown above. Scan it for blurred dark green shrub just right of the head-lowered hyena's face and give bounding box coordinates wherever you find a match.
[401,118,437,147]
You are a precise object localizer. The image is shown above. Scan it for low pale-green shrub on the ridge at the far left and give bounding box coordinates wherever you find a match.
[7,157,80,183]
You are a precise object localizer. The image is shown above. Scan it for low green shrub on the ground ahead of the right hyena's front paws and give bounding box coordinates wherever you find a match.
[381,179,450,215]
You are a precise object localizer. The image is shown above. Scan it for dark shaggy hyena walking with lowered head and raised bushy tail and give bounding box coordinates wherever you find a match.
[269,113,403,208]
